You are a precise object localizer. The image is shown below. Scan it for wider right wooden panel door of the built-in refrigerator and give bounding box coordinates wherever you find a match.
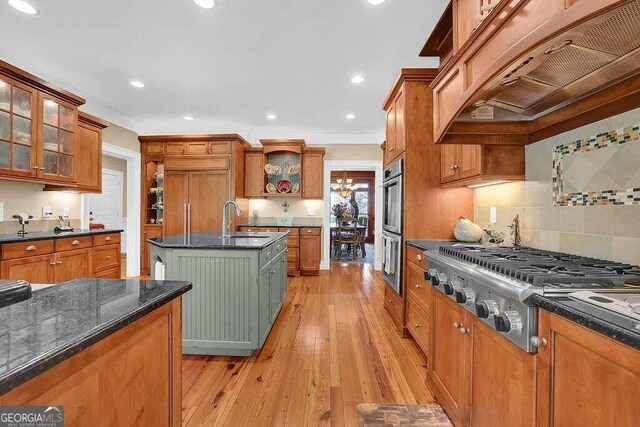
[187,171,230,233]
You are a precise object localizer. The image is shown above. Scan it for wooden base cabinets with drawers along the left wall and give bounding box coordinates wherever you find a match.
[0,232,121,283]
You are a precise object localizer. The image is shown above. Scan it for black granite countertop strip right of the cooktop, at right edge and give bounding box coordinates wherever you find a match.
[527,295,640,350]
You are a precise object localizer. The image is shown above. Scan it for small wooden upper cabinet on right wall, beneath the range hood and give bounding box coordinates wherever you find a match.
[440,144,525,187]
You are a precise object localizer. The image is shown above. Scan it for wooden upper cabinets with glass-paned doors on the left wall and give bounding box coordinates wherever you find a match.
[0,61,107,192]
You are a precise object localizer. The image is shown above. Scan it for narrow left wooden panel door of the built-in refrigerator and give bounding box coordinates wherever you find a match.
[164,171,189,236]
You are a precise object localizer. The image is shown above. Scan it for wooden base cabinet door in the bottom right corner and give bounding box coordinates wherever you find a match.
[536,309,640,427]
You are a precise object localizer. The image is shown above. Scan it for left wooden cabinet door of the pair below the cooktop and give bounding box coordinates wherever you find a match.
[431,292,469,425]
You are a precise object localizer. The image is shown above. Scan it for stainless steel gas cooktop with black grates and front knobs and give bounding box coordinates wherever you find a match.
[425,244,640,352]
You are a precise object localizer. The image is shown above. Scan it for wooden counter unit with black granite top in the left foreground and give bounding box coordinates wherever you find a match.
[0,279,191,426]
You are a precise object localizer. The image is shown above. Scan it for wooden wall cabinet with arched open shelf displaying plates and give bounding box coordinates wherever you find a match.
[245,139,326,199]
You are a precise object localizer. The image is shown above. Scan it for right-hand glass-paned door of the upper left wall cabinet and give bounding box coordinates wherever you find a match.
[39,95,77,181]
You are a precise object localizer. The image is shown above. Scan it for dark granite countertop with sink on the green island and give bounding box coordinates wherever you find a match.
[147,232,289,249]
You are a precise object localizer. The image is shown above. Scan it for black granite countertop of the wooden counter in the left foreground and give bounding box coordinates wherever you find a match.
[0,279,192,394]
